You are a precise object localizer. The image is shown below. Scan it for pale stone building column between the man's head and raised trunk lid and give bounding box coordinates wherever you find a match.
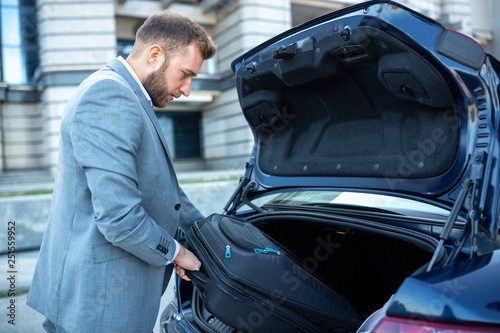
[201,0,291,170]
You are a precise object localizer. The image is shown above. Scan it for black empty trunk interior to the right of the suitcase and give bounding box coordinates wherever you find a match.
[251,213,444,319]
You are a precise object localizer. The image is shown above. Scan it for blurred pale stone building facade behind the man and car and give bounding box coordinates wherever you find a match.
[0,0,500,175]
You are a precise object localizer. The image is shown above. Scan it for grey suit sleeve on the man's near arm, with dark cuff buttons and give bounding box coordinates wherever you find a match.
[71,79,175,266]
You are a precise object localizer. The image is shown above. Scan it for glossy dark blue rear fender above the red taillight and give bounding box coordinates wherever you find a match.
[387,250,500,329]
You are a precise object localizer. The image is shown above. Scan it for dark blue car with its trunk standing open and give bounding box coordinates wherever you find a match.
[161,1,500,333]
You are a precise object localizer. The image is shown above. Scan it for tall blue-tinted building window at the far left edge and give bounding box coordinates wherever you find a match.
[0,0,38,85]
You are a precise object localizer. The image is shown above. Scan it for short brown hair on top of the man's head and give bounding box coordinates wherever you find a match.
[130,10,216,61]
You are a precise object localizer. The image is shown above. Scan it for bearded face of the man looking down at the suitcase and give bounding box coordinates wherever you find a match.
[143,44,203,108]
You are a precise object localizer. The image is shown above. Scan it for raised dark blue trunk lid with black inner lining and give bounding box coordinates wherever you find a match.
[232,1,500,237]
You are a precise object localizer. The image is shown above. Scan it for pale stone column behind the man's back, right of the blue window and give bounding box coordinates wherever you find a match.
[37,0,116,175]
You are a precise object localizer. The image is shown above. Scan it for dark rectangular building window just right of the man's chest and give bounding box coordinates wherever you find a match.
[156,111,201,159]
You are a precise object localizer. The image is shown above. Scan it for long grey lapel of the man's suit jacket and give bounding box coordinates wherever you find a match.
[107,59,176,164]
